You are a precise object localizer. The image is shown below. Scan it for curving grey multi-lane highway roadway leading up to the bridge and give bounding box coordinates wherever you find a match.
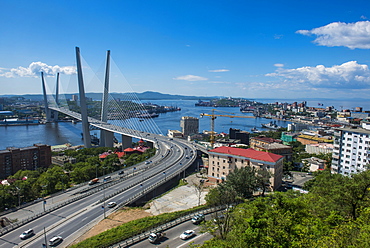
[0,110,196,248]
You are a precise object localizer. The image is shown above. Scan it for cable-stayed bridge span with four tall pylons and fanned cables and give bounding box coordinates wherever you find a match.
[41,47,165,149]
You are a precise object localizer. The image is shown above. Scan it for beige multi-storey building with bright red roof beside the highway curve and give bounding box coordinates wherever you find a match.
[208,146,284,190]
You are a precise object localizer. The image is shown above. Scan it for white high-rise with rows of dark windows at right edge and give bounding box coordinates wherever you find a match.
[331,125,370,175]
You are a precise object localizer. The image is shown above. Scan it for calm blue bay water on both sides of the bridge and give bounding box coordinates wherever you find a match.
[0,99,370,150]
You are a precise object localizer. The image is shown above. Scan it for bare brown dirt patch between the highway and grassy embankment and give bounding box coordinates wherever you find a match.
[73,208,152,244]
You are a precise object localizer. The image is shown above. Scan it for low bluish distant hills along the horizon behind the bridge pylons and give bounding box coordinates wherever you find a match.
[0,91,217,101]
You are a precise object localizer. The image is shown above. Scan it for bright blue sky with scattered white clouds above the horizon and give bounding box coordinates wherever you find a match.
[0,0,370,99]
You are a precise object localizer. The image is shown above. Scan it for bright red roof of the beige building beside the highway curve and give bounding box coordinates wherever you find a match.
[209,146,283,162]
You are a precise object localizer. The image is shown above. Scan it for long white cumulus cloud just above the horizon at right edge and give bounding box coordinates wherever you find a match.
[266,61,370,89]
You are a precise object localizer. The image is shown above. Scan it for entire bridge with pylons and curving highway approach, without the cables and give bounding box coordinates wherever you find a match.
[0,48,208,248]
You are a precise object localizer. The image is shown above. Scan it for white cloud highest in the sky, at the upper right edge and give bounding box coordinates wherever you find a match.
[296,21,370,49]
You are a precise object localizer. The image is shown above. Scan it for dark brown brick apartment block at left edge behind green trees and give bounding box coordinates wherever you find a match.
[0,144,51,179]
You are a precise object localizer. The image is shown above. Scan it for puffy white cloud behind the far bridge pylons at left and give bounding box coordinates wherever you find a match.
[0,62,77,78]
